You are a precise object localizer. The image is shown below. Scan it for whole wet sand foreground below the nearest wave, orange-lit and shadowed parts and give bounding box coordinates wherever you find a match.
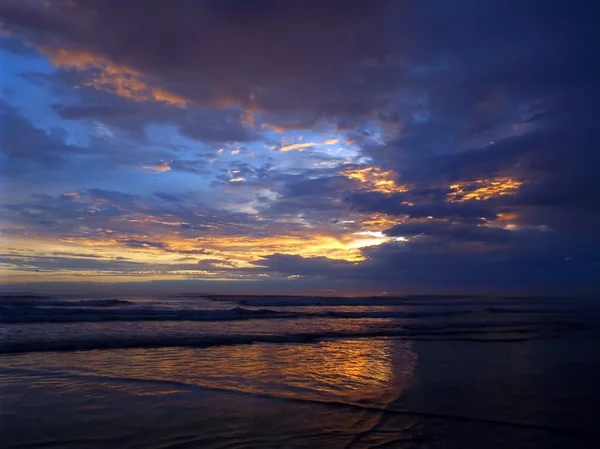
[0,336,600,449]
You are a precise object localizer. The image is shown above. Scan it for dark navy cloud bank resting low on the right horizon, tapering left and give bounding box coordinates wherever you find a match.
[257,234,600,291]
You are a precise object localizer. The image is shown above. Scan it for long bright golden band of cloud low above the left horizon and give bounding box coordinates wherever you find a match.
[0,228,380,283]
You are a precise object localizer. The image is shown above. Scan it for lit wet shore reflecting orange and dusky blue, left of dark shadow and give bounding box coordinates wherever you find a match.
[0,339,417,447]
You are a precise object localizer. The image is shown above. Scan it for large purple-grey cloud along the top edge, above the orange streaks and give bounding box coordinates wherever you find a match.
[2,0,400,117]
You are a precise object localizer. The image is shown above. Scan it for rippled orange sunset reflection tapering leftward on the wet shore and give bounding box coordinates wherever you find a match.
[4,339,417,406]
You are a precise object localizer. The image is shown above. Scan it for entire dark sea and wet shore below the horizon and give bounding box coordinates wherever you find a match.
[0,295,600,449]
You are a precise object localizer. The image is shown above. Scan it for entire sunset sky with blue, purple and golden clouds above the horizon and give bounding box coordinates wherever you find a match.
[0,0,600,294]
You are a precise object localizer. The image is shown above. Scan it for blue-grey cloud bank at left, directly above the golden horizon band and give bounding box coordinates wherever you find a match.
[2,188,262,247]
